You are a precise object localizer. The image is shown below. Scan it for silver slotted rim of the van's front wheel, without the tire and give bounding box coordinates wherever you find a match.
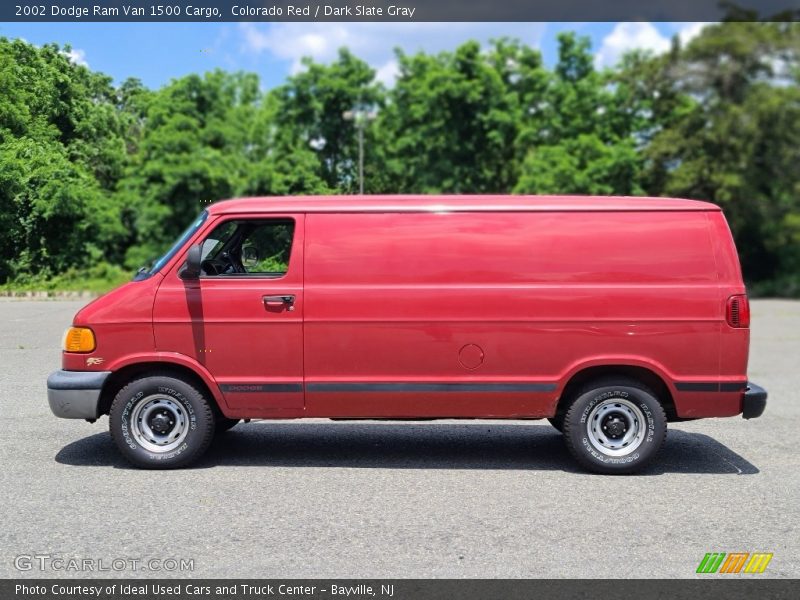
[130,394,189,454]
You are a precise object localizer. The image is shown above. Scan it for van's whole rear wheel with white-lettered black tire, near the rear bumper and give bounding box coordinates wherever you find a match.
[563,378,667,475]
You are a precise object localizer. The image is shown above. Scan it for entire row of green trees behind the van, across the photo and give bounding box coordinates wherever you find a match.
[0,22,800,295]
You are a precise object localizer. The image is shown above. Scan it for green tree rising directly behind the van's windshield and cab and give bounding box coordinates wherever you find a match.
[117,70,327,267]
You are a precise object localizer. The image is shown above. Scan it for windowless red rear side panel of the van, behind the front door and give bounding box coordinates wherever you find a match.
[304,211,724,417]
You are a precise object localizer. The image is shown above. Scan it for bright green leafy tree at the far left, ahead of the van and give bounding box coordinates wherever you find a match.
[0,38,126,281]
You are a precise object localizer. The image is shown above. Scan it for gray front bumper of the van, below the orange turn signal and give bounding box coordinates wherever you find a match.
[47,370,111,419]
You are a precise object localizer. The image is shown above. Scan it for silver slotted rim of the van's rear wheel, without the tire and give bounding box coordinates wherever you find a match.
[586,398,646,456]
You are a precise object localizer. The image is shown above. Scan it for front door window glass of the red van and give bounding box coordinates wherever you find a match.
[201,219,294,278]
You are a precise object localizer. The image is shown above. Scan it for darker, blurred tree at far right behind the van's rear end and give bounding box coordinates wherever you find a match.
[644,22,800,293]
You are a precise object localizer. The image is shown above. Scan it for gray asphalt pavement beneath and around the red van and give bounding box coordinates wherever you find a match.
[0,299,800,578]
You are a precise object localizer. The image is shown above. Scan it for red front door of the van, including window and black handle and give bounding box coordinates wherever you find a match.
[153,215,304,417]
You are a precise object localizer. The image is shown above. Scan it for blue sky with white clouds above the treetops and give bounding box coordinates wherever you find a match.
[0,22,703,88]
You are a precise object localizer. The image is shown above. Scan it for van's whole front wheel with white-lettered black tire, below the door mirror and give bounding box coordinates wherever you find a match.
[109,373,214,469]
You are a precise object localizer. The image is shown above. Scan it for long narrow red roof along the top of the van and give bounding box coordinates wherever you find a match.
[208,194,720,214]
